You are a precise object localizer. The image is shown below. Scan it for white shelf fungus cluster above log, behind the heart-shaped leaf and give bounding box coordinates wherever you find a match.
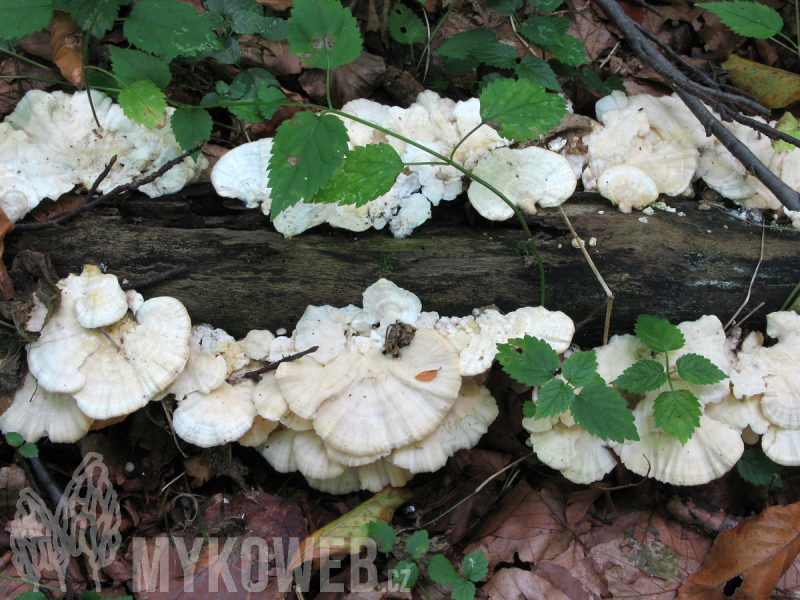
[211,91,511,238]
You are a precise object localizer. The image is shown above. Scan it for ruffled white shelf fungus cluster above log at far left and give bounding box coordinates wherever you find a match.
[0,90,208,222]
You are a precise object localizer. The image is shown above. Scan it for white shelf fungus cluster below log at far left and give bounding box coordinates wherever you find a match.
[0,265,191,442]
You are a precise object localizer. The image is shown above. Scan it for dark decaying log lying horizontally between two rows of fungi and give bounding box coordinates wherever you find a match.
[6,186,800,345]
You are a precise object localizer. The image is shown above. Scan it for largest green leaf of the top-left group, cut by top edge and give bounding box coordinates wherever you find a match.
[123,0,222,62]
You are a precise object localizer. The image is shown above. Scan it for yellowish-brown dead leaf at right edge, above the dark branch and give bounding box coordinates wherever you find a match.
[722,54,800,108]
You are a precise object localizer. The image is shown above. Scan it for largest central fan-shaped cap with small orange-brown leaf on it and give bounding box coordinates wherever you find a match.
[277,329,461,456]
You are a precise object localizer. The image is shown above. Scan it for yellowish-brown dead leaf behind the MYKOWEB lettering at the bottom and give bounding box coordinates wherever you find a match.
[287,486,412,571]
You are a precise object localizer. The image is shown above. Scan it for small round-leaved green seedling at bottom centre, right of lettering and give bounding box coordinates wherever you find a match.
[364,521,489,600]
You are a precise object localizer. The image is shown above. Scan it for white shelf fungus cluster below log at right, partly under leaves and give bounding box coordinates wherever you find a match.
[523,312,800,485]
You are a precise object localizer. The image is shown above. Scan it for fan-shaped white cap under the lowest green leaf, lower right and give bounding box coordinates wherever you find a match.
[611,394,744,485]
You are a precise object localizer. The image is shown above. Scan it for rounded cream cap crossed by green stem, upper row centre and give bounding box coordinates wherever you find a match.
[467,147,577,221]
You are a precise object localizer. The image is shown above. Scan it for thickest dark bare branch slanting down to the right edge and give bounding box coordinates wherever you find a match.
[595,0,800,210]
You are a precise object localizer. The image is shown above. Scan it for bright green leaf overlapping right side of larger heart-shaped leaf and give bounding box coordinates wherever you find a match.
[309,144,403,207]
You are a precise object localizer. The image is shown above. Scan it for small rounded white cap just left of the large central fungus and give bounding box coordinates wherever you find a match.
[172,379,258,448]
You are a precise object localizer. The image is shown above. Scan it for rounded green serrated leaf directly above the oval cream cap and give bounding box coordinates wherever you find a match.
[480,79,567,142]
